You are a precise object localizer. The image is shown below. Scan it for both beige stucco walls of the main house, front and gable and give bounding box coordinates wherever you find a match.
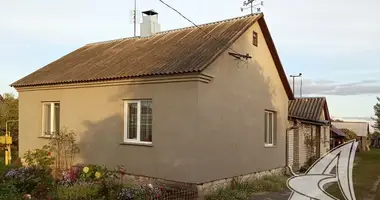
[14,20,288,183]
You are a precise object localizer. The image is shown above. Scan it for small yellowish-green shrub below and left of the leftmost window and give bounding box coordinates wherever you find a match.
[24,145,55,168]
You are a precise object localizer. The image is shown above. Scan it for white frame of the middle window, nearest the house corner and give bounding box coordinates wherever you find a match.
[124,99,153,144]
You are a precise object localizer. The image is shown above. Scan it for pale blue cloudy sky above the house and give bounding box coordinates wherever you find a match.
[0,0,380,120]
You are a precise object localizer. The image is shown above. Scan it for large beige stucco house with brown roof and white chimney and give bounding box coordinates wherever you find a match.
[12,11,293,189]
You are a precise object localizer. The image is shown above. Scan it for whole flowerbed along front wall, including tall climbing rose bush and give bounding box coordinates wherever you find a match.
[0,128,196,200]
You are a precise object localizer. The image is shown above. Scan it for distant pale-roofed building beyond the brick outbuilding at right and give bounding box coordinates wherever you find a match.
[332,121,370,150]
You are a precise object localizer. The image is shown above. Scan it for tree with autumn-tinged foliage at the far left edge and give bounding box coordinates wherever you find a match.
[0,93,18,157]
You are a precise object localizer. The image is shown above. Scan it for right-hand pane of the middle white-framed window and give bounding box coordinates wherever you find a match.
[140,101,152,142]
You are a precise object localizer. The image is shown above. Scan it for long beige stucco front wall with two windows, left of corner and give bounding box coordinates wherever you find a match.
[19,82,204,182]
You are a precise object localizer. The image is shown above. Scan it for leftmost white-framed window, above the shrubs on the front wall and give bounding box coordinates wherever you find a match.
[42,102,60,136]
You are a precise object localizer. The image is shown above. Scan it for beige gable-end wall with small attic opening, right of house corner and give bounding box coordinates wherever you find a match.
[198,24,288,181]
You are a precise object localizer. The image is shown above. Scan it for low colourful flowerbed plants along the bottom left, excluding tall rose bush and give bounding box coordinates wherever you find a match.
[0,162,169,200]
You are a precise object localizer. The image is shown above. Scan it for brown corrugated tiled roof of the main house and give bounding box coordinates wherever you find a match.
[11,14,293,99]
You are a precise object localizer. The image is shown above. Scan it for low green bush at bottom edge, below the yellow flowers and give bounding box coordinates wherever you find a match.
[56,183,99,200]
